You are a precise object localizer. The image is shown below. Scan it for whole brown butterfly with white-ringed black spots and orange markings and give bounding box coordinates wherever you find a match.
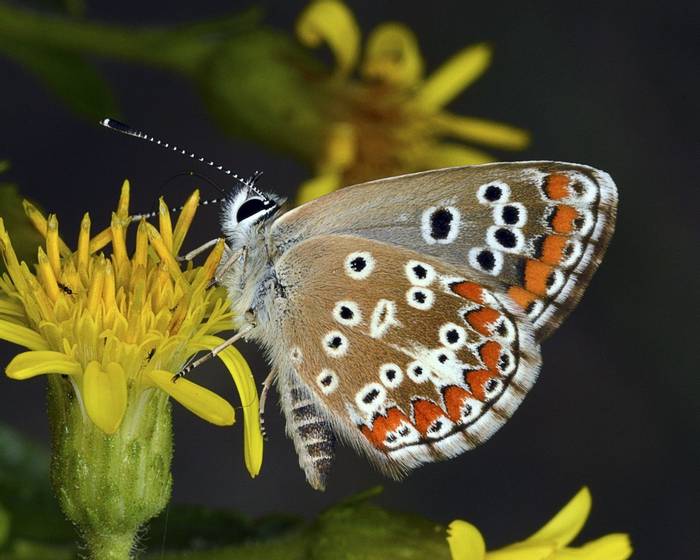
[101,119,617,489]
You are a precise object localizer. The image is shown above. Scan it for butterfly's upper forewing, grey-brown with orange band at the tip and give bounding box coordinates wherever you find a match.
[272,162,617,340]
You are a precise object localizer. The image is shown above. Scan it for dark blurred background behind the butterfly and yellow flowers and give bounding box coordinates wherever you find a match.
[0,0,700,559]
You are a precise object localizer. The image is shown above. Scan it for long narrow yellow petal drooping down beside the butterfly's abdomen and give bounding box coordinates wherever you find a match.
[193,336,263,477]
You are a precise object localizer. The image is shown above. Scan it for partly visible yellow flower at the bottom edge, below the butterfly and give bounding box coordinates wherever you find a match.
[447,488,632,560]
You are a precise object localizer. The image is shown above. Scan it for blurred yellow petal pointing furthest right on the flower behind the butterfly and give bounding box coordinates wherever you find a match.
[433,113,530,150]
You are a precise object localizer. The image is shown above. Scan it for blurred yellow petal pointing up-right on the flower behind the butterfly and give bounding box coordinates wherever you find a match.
[415,43,491,111]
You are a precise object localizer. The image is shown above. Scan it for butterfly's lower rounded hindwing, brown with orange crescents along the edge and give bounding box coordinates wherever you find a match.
[273,235,540,478]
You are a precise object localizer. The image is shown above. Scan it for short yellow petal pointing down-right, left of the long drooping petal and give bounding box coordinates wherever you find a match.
[148,369,236,426]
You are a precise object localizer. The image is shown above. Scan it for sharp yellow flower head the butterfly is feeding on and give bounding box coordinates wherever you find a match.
[0,181,262,476]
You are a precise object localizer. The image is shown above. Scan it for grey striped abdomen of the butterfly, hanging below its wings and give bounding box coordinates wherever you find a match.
[277,371,335,490]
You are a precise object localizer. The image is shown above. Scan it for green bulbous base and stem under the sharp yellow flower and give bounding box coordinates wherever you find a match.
[48,376,172,560]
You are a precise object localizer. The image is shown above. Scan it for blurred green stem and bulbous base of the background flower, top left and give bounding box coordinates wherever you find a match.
[0,2,328,163]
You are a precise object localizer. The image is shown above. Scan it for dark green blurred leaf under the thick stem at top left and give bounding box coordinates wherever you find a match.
[0,40,117,121]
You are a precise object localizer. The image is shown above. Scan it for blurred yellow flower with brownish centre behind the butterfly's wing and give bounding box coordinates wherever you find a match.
[297,0,529,203]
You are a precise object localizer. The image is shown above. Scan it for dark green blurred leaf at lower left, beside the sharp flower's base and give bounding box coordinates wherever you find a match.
[0,424,75,544]
